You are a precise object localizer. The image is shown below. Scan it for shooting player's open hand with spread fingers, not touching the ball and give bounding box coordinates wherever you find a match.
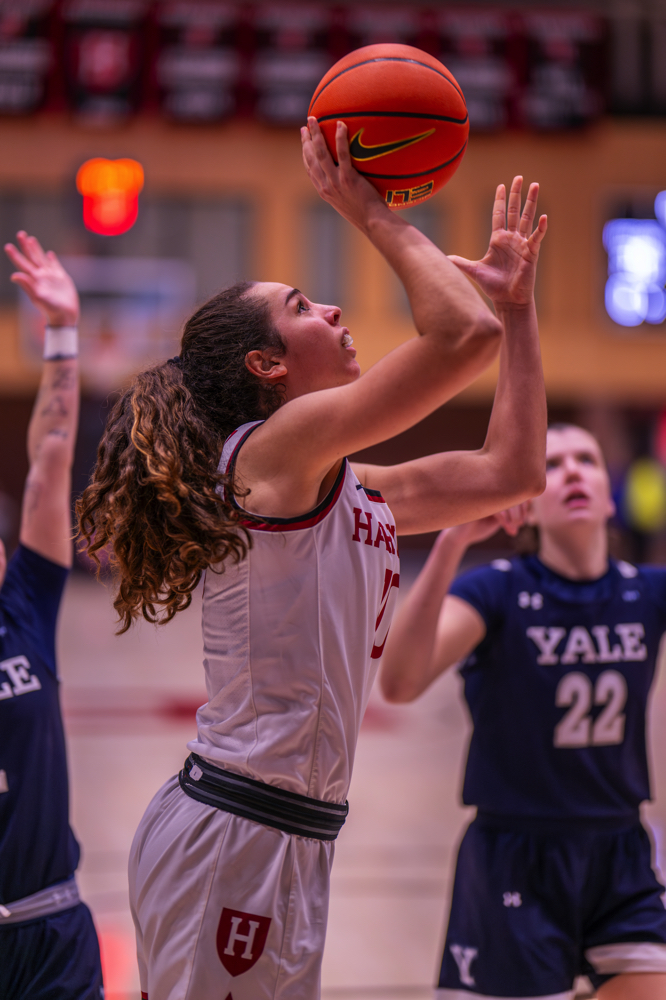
[449,177,548,308]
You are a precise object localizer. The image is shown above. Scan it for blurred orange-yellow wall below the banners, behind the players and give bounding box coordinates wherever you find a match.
[0,116,666,403]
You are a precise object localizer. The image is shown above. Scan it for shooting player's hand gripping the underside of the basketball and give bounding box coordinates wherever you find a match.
[301,117,391,230]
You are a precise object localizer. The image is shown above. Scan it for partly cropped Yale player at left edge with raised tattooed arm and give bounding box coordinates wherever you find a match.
[0,232,104,1000]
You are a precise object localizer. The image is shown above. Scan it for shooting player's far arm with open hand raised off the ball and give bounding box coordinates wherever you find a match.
[356,177,547,534]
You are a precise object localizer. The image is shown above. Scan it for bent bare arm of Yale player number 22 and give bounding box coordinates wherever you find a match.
[379,505,524,702]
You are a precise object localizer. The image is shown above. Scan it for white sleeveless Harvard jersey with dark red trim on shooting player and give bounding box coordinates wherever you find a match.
[188,421,400,803]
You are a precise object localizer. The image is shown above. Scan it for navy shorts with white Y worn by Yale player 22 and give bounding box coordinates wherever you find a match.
[439,817,666,1000]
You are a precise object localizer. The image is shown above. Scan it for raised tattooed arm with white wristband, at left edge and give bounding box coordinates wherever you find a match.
[5,232,79,566]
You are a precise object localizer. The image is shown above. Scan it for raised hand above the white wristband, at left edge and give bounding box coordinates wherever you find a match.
[5,230,79,326]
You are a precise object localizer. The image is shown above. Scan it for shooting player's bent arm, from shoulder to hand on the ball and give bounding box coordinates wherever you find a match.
[238,119,502,508]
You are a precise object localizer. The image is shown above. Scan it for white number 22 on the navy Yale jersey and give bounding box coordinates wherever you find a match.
[553,670,627,747]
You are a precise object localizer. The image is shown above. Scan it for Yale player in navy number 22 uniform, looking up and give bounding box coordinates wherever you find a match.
[381,425,666,1000]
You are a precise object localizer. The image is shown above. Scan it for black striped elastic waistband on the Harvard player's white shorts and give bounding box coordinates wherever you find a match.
[178,753,349,840]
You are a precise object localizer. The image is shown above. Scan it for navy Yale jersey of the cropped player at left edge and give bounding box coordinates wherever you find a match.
[0,545,79,903]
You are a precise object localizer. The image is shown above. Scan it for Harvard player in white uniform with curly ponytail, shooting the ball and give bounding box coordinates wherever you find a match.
[79,119,546,1000]
